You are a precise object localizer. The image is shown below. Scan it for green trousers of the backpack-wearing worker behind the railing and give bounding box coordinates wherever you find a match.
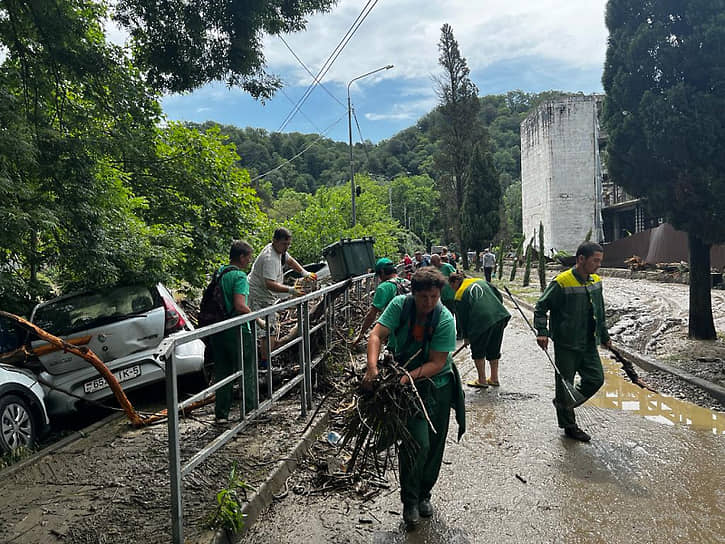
[211,328,257,419]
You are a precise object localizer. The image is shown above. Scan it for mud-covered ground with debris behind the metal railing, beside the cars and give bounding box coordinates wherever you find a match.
[0,395,326,544]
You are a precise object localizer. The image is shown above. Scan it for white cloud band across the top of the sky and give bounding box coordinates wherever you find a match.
[265,0,607,84]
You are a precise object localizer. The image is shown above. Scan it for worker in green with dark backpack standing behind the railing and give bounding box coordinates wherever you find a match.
[210,240,257,422]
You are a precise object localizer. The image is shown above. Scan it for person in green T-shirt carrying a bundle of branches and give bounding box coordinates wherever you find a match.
[363,268,465,528]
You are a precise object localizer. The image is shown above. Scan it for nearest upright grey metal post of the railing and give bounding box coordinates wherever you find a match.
[166,345,184,544]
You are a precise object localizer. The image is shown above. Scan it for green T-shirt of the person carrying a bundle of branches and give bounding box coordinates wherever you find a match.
[378,295,456,387]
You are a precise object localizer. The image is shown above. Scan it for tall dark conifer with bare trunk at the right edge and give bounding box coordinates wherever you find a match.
[603,0,725,338]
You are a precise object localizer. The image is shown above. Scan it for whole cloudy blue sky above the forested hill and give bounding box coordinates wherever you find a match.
[162,0,607,142]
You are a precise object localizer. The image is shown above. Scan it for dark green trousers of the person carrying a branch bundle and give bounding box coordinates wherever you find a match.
[398,381,453,506]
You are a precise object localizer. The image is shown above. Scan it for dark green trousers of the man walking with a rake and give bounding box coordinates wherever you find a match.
[554,342,604,428]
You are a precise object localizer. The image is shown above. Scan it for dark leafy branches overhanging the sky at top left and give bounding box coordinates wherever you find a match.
[114,0,335,98]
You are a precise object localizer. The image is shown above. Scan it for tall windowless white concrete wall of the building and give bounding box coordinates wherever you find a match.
[521,96,596,254]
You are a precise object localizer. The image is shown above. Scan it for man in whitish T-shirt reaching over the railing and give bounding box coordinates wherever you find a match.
[249,227,311,366]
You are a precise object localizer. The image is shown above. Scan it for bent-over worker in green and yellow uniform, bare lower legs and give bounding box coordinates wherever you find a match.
[448,273,511,387]
